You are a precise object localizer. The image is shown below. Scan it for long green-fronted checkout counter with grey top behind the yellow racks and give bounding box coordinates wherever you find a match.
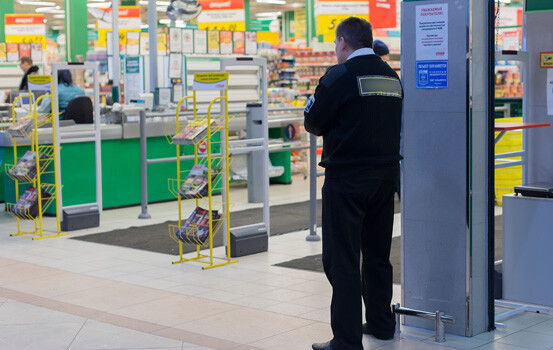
[0,106,303,214]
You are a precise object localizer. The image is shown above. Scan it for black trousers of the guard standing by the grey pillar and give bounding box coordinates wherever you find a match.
[322,167,398,350]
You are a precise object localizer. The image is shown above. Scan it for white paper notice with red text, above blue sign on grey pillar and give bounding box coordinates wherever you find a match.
[416,4,449,61]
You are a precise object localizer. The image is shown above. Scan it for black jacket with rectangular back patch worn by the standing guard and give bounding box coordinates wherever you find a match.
[304,55,403,175]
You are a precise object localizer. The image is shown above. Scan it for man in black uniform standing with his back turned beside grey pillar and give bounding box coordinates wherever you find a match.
[304,17,403,350]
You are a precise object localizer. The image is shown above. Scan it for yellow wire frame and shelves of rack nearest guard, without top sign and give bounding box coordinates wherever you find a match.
[166,73,237,269]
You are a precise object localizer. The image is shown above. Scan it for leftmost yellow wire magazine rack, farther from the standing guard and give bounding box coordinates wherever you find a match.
[5,91,67,239]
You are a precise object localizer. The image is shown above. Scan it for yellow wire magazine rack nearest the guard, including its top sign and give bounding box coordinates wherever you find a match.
[166,72,237,269]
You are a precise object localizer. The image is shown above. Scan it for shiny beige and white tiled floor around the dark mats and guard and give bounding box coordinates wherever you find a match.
[0,179,553,350]
